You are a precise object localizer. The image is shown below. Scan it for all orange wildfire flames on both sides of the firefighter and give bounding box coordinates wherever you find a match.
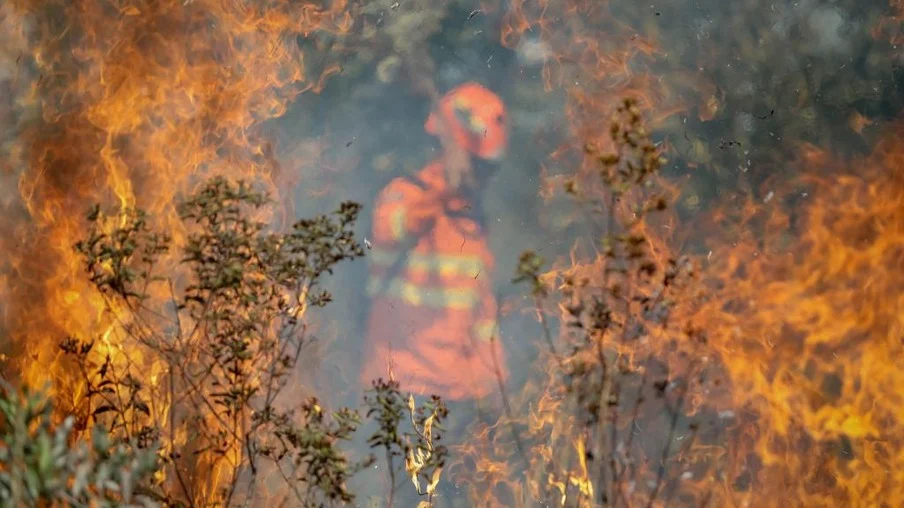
[0,0,904,506]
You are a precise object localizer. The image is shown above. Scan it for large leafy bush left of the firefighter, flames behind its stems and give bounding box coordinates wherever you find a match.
[60,178,363,506]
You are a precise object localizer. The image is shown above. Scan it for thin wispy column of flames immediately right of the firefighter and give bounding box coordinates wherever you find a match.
[444,0,700,506]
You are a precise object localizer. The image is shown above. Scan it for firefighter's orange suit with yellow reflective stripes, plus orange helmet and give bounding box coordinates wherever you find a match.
[361,84,507,401]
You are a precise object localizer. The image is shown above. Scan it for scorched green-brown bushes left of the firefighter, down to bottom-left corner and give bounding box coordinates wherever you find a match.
[0,178,445,506]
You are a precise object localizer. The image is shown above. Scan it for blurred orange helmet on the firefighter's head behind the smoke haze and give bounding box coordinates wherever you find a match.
[424,83,508,160]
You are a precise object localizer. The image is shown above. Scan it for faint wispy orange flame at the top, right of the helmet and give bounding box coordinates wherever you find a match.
[500,0,696,240]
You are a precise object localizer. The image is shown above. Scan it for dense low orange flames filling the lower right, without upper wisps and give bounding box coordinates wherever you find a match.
[477,106,904,506]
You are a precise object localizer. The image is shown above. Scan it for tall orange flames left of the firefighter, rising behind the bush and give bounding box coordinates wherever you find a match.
[0,0,352,504]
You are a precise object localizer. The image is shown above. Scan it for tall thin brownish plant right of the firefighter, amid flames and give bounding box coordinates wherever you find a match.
[514,99,701,506]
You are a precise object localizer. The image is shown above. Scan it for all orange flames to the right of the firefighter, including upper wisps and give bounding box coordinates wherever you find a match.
[458,2,904,506]
